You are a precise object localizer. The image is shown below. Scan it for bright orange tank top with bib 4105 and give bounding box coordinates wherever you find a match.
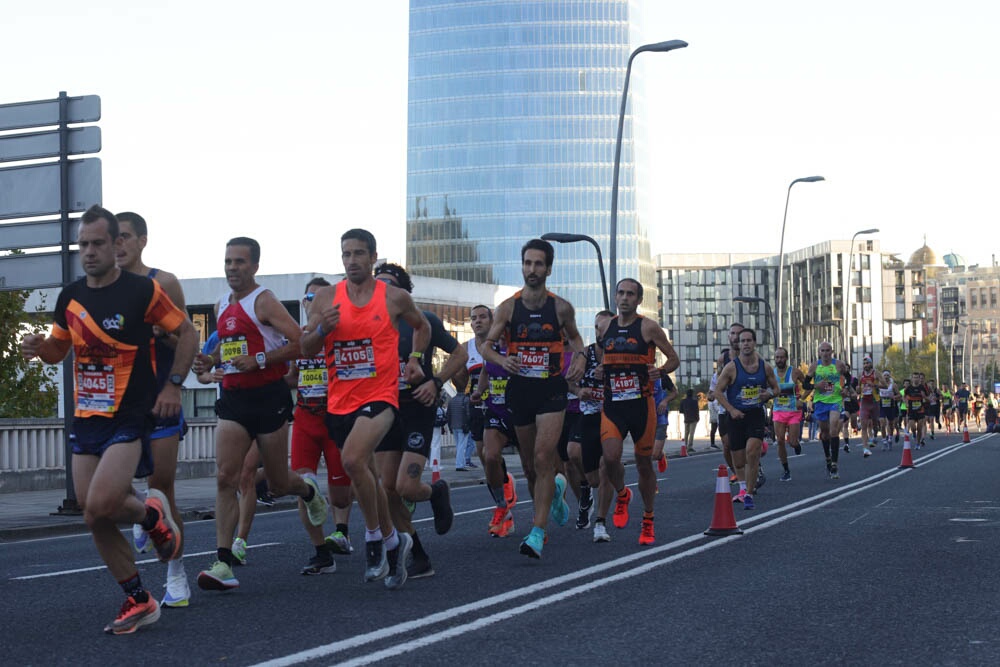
[323,280,399,415]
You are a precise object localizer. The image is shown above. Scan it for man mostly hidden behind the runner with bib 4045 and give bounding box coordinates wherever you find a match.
[115,212,191,607]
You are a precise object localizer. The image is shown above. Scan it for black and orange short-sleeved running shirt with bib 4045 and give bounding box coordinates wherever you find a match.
[52,271,185,418]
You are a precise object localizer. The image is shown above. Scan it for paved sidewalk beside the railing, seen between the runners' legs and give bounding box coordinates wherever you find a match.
[0,438,708,542]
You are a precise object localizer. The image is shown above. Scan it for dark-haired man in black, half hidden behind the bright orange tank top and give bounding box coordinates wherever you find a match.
[375,263,468,581]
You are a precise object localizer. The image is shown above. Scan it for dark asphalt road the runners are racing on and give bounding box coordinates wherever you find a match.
[0,436,1000,666]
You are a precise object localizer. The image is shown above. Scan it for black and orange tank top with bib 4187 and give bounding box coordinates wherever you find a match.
[603,315,656,408]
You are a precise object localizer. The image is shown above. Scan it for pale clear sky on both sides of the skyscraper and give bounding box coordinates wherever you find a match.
[0,0,1000,278]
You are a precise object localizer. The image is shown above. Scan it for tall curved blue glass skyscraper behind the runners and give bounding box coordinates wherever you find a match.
[406,0,656,338]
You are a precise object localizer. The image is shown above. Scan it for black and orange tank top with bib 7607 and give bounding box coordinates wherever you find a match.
[507,290,563,379]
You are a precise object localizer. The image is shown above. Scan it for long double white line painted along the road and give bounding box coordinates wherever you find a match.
[257,443,984,667]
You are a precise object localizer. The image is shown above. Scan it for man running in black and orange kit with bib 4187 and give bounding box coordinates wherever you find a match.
[597,278,680,545]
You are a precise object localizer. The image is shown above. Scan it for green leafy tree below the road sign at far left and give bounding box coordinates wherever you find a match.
[0,290,59,419]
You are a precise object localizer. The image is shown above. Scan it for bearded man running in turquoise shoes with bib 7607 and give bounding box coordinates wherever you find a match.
[479,239,586,558]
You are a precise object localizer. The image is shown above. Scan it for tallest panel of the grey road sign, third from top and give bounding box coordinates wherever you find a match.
[0,158,101,220]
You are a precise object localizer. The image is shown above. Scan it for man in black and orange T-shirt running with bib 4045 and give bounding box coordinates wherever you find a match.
[21,205,197,635]
